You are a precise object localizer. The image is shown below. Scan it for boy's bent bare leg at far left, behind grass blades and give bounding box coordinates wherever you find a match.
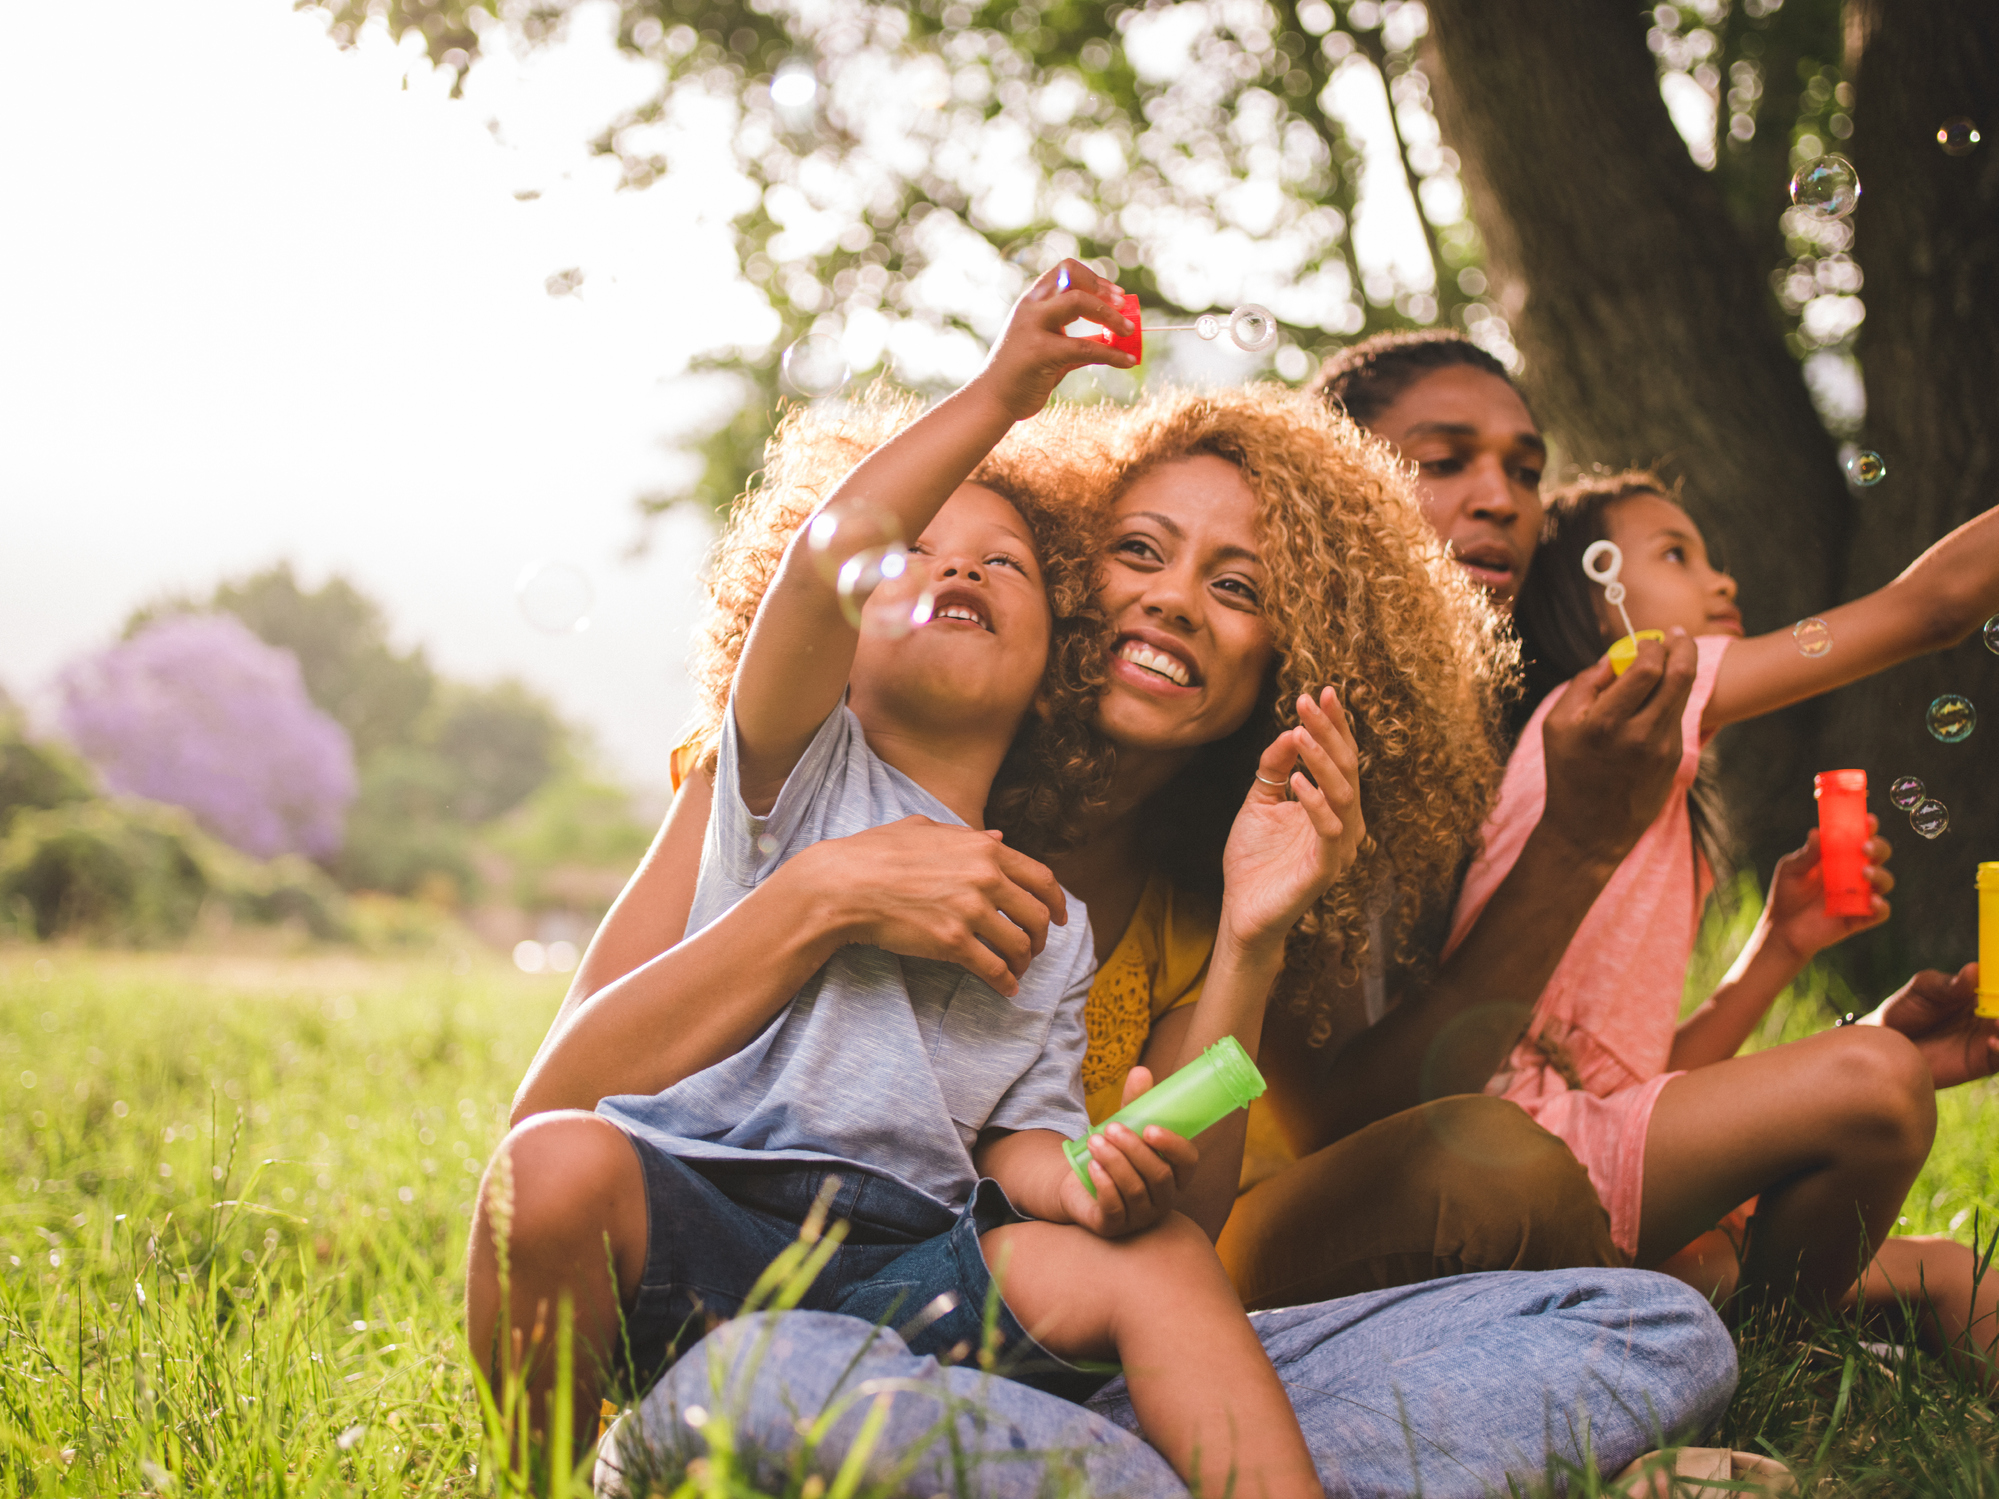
[466,1111,646,1447]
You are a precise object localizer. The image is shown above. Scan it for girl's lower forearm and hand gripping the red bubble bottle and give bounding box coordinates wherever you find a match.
[1665,817,1895,1071]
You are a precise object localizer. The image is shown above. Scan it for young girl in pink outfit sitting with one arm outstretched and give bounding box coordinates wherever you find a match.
[1451,474,1999,1347]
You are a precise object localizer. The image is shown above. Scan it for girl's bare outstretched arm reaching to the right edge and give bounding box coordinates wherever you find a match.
[1701,506,1999,732]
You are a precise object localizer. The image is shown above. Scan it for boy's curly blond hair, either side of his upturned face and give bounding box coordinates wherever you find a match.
[692,388,1113,857]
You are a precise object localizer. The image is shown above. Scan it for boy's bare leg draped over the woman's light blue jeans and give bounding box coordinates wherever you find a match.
[980,1213,1323,1499]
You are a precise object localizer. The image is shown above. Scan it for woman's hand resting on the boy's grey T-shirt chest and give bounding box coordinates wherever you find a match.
[774,815,1069,997]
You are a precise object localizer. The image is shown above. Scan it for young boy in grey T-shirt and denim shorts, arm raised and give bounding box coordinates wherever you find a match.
[474,262,1339,1499]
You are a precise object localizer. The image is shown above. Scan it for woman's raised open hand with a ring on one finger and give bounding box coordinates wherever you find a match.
[1221,688,1367,963]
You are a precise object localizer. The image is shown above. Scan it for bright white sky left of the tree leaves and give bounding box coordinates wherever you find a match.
[0,0,754,799]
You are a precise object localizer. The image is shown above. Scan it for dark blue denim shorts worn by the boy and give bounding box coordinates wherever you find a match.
[616,1133,1115,1401]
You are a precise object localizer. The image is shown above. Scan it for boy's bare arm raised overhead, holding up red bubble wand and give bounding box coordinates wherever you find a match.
[736,260,1135,809]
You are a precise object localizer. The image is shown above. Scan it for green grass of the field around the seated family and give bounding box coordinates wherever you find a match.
[11,947,1999,1495]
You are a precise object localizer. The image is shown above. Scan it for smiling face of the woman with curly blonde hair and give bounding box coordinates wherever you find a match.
[1099,454,1277,751]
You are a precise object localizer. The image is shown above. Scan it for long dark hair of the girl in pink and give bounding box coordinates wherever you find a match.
[1507,468,1733,881]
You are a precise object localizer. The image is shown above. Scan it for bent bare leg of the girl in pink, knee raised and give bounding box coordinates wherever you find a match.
[1637,1025,1937,1307]
